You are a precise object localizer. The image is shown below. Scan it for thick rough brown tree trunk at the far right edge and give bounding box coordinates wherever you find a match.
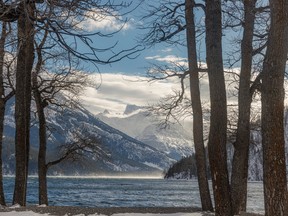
[261,0,288,216]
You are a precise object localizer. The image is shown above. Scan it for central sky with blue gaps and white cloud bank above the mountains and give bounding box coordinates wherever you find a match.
[76,1,207,114]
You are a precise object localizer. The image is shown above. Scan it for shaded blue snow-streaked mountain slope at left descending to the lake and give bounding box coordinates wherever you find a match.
[3,100,175,175]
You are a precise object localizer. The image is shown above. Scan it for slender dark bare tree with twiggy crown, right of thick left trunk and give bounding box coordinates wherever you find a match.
[32,31,88,205]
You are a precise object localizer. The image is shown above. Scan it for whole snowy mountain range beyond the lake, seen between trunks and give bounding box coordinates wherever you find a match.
[3,97,278,181]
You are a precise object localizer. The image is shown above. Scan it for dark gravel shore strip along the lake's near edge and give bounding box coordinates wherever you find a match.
[0,206,262,216]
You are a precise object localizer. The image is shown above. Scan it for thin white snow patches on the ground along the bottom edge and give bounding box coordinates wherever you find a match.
[0,211,207,216]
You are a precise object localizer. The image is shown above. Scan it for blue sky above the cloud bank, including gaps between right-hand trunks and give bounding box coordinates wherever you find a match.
[76,0,236,76]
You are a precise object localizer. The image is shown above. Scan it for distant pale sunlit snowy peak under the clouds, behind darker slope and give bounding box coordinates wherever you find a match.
[97,105,194,160]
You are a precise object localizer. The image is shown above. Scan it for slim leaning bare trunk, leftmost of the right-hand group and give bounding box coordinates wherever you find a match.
[185,0,213,211]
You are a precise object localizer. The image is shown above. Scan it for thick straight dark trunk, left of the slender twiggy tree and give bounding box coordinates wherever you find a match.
[13,2,34,206]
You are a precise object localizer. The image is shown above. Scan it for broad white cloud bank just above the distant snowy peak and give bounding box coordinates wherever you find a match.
[81,74,180,114]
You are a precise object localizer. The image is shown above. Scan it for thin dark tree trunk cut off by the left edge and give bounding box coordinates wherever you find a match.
[0,22,6,206]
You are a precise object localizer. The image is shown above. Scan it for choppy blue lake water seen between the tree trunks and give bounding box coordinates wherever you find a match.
[4,177,264,212]
